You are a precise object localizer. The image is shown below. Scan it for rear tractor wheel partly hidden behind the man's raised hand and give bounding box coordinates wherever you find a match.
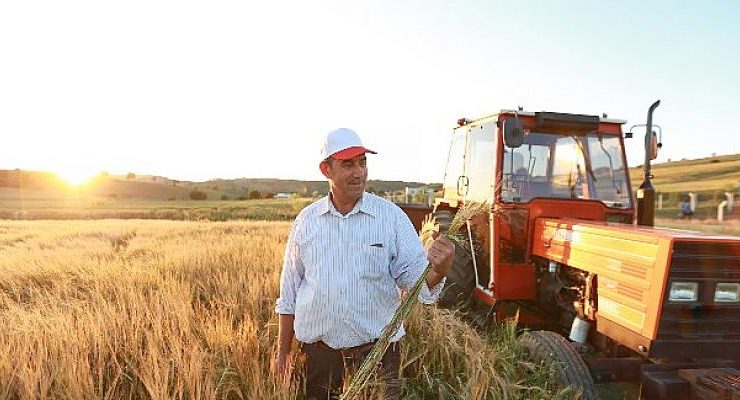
[420,210,475,308]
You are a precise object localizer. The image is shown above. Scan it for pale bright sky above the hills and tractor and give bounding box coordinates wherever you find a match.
[0,0,740,182]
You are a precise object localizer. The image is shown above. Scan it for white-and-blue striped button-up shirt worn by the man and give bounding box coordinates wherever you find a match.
[275,193,444,349]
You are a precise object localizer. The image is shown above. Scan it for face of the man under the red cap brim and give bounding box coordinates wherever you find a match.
[322,154,367,200]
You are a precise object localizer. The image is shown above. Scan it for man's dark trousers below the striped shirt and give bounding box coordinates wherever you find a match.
[301,342,401,400]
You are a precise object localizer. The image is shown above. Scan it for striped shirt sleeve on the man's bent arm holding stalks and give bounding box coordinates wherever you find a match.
[390,210,447,304]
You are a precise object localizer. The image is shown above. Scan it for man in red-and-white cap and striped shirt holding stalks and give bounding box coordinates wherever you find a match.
[275,129,455,399]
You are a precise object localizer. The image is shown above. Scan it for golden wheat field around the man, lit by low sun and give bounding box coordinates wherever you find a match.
[0,220,576,399]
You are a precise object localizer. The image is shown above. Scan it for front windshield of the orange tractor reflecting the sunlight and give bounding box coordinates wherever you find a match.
[501,132,632,208]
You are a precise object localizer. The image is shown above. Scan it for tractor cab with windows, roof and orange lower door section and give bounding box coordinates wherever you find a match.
[437,111,635,303]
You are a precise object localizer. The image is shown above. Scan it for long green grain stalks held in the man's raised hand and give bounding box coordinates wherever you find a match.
[341,202,488,400]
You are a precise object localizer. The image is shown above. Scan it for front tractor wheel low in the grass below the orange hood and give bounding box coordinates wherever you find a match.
[519,331,598,400]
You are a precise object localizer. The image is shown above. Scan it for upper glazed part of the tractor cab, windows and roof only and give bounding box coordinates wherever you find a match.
[443,111,633,212]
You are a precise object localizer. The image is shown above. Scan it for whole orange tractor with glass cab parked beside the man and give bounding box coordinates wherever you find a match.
[402,102,740,399]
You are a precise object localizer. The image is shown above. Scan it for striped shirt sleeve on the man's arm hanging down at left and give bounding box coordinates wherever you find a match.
[275,215,304,314]
